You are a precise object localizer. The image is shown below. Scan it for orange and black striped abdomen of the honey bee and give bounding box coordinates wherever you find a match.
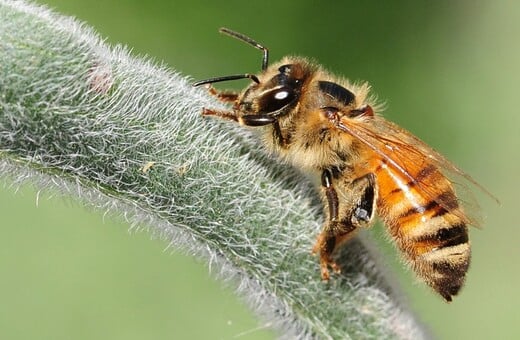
[375,161,471,301]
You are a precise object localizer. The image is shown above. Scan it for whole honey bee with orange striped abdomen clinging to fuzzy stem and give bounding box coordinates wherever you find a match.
[194,28,488,302]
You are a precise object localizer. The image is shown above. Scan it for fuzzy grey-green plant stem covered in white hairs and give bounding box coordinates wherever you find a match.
[0,0,425,339]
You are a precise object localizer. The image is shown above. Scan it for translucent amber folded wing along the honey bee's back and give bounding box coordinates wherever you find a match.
[337,116,498,225]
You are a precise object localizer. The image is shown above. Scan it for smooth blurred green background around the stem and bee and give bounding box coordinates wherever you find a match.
[0,0,520,340]
